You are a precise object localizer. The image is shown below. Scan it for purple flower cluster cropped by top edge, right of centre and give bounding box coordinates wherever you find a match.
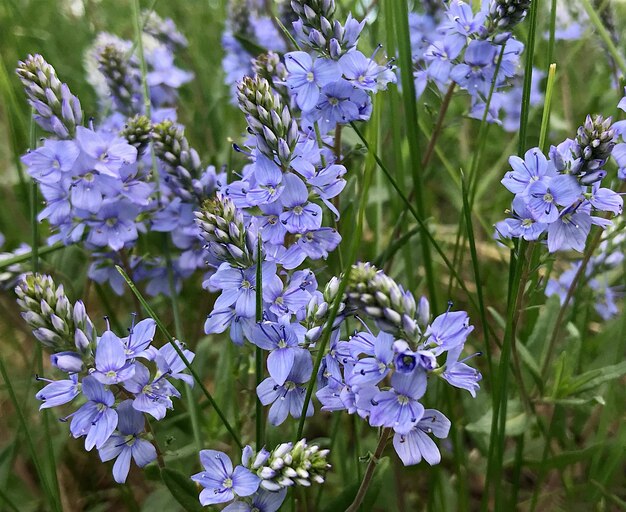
[409,0,543,131]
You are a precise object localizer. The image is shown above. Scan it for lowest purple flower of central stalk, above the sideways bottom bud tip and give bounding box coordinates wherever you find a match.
[256,350,313,426]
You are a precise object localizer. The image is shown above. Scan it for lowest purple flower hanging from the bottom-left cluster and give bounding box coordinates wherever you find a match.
[98,400,157,484]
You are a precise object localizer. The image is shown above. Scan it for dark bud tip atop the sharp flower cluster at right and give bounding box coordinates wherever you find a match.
[576,115,616,180]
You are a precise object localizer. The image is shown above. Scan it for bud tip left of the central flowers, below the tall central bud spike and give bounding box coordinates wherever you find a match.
[195,193,256,268]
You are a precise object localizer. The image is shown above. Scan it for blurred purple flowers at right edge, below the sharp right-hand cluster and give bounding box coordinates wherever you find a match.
[546,222,626,320]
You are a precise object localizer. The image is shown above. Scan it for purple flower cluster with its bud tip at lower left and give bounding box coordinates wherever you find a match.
[15,274,194,483]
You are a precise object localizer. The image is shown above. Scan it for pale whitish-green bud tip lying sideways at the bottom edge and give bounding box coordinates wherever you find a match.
[248,439,330,491]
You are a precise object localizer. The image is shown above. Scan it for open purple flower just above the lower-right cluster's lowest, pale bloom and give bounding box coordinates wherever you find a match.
[370,369,426,434]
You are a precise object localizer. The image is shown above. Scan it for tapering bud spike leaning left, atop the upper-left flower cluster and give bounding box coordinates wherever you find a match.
[16,54,83,139]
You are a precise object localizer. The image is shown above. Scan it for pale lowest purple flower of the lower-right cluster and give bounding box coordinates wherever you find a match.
[393,409,450,466]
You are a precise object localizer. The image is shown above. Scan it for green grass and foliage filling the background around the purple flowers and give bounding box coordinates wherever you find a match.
[0,0,626,512]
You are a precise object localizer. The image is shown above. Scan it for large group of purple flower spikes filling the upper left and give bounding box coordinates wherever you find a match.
[18,13,217,294]
